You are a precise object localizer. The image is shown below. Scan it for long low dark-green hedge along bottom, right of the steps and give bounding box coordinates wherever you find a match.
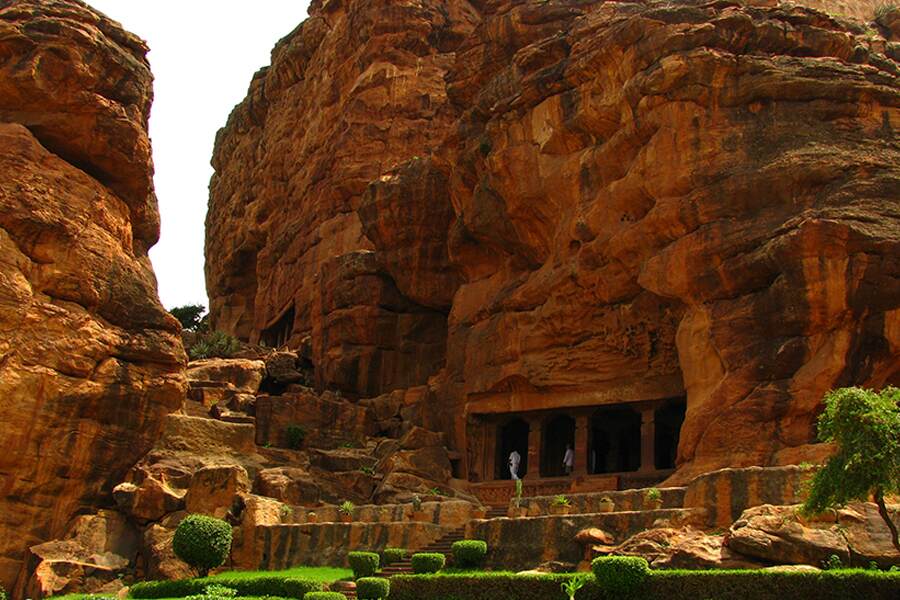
[390,569,900,600]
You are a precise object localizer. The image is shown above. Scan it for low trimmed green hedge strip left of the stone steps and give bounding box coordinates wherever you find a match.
[128,575,325,600]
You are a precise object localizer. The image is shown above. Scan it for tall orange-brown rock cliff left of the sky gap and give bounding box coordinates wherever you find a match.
[0,0,185,591]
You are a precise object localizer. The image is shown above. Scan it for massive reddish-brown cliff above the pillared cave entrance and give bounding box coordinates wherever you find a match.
[206,0,900,482]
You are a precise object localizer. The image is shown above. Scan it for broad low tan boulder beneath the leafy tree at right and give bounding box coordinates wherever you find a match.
[727,502,900,567]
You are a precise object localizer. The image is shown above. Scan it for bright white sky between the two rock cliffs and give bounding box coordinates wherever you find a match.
[87,0,309,308]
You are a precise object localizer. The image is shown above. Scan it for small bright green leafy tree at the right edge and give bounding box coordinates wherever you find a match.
[803,387,900,551]
